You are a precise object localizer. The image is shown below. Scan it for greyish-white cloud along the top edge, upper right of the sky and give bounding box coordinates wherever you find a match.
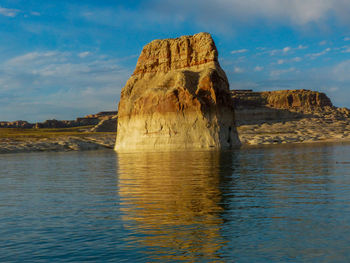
[149,0,350,27]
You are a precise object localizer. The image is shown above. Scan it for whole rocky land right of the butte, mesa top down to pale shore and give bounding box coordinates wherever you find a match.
[232,90,350,145]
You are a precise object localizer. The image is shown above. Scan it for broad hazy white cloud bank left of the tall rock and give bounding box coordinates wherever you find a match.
[0,51,131,121]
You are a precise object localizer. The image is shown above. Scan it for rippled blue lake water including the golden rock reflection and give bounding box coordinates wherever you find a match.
[0,144,350,262]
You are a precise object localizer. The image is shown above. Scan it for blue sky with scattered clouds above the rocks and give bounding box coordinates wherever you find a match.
[0,0,350,122]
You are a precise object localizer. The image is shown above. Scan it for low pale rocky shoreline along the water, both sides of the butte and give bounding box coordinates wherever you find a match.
[0,118,350,154]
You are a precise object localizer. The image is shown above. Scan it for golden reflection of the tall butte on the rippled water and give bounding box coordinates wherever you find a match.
[118,152,231,261]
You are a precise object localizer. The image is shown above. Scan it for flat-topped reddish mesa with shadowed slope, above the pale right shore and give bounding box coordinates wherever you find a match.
[231,89,346,125]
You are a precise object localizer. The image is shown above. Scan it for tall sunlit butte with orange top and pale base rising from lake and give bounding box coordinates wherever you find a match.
[115,33,240,151]
